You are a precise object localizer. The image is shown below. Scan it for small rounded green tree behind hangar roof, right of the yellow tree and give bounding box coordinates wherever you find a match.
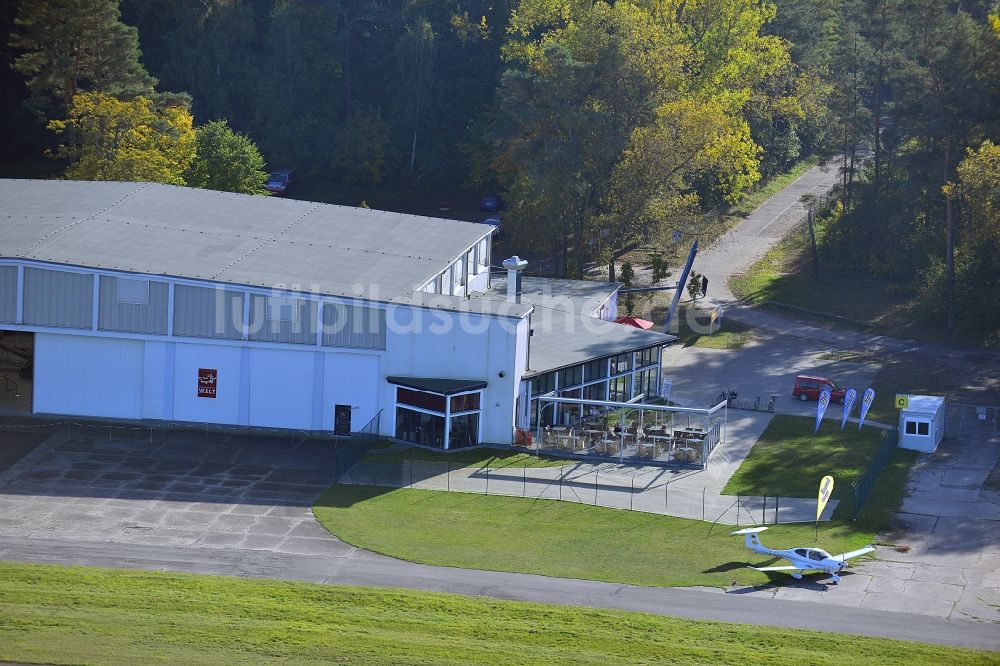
[184,120,267,194]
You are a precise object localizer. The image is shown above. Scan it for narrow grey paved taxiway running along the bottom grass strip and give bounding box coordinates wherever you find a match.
[0,538,1000,651]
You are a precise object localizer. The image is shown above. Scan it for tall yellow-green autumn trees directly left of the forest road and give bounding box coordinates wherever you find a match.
[492,0,788,274]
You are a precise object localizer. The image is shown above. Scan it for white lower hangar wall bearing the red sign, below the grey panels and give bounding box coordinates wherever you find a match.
[34,333,382,430]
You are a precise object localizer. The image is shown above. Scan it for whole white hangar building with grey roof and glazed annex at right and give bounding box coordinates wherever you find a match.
[0,180,673,448]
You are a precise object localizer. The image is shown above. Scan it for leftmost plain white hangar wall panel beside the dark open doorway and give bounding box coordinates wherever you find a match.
[33,333,143,419]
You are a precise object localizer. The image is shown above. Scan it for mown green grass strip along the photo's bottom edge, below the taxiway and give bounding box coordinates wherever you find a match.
[0,563,997,666]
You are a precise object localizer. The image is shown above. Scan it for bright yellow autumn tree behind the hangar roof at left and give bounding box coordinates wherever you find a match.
[49,93,195,185]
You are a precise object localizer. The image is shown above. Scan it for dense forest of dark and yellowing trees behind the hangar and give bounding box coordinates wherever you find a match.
[0,0,1000,328]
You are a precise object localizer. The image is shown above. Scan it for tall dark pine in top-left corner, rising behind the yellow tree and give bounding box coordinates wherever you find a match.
[10,0,156,118]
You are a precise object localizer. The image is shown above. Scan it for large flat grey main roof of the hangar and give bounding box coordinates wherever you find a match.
[0,180,493,301]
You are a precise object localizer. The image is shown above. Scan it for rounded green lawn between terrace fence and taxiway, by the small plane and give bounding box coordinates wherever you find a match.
[313,485,873,587]
